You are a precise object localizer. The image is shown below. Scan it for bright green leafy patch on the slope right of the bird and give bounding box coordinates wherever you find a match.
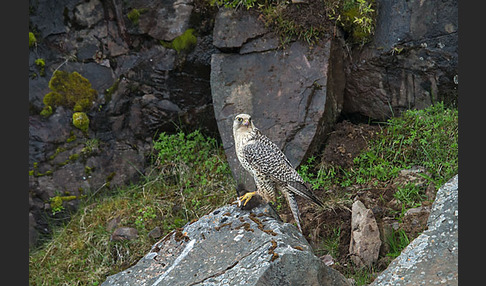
[298,103,458,193]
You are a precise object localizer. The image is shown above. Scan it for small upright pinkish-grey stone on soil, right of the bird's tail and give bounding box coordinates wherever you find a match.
[349,200,381,267]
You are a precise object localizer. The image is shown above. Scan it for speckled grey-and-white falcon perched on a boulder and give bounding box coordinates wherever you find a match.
[233,113,323,233]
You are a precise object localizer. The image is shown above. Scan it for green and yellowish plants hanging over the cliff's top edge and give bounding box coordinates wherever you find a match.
[209,0,376,46]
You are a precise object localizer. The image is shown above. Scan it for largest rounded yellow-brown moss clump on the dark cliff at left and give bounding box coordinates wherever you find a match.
[43,71,97,116]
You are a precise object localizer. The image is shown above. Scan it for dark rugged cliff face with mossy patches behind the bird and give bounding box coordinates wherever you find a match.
[29,0,458,255]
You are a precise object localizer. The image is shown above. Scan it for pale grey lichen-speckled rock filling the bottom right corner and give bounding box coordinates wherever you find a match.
[370,175,459,285]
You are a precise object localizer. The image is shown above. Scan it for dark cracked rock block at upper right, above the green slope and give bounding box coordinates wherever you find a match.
[343,0,458,120]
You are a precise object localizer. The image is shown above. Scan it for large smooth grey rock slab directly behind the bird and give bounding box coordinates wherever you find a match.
[211,9,344,190]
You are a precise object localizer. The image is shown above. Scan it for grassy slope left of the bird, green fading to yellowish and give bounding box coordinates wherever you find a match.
[29,131,235,285]
